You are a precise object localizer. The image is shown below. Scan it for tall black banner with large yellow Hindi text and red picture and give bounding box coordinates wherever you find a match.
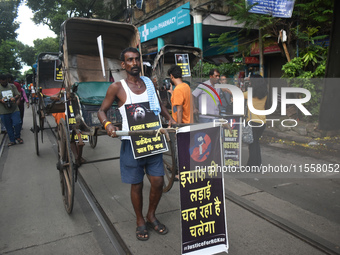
[177,124,228,255]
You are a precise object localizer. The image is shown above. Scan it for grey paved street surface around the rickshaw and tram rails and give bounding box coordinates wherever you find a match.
[0,110,340,255]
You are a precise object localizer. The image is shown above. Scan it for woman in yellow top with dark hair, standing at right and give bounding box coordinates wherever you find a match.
[243,74,268,166]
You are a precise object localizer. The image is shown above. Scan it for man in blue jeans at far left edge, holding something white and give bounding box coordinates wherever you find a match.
[0,74,23,146]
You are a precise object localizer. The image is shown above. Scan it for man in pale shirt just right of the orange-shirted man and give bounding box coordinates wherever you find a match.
[192,69,220,123]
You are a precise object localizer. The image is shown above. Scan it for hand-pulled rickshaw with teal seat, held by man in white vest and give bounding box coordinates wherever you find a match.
[57,18,175,213]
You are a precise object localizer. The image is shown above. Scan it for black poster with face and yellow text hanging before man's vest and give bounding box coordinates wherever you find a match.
[125,102,168,159]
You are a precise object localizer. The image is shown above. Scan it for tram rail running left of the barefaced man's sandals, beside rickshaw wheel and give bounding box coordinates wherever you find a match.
[45,119,132,255]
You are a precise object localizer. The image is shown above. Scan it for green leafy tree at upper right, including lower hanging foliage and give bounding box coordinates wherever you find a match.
[210,0,334,117]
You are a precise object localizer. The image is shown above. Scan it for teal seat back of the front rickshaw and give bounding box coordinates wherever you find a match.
[72,81,112,105]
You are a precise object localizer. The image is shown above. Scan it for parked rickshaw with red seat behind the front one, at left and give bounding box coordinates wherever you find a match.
[30,52,65,155]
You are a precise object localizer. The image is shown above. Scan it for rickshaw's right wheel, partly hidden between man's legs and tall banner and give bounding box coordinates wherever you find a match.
[163,133,177,193]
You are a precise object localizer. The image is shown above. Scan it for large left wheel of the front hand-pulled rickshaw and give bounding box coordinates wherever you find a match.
[57,119,75,214]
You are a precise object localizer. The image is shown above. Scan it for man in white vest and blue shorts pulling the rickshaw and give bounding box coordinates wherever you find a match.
[98,47,175,241]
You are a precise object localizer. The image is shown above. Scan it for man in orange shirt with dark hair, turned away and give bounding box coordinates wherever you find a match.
[168,65,192,123]
